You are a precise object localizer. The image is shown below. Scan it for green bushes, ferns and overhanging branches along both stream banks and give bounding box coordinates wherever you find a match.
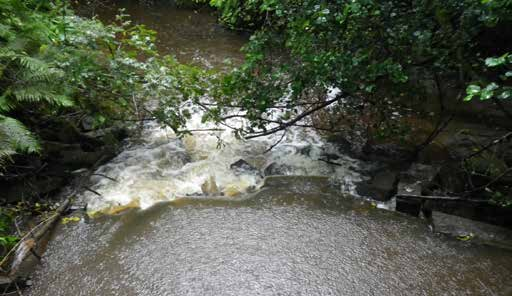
[0,0,512,278]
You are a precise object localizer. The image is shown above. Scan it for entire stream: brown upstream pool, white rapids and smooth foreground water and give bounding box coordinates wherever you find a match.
[26,1,512,296]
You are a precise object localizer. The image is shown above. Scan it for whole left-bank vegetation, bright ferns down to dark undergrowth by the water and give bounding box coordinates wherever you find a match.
[0,0,204,260]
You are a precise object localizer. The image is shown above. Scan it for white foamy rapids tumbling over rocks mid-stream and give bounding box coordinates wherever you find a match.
[82,92,361,211]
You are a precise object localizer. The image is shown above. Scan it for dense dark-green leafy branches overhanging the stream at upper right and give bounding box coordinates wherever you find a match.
[187,0,512,136]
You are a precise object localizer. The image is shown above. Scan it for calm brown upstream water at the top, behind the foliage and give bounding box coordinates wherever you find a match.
[76,0,247,67]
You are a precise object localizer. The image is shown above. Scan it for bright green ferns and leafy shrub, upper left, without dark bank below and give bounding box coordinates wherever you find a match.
[0,0,192,161]
